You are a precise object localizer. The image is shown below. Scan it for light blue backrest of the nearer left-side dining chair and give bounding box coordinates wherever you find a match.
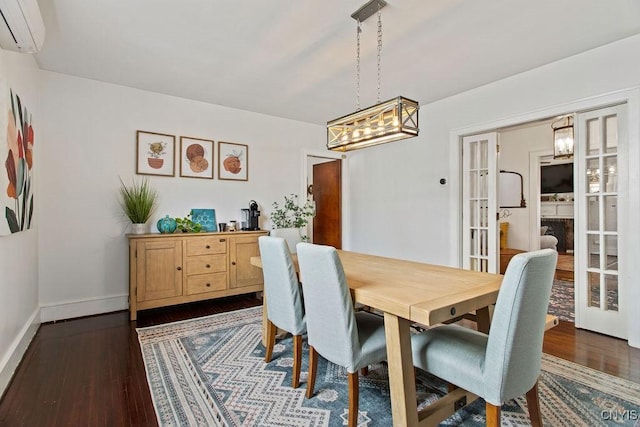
[297,243,361,372]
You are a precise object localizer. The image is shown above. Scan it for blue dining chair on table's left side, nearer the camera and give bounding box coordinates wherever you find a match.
[296,243,387,426]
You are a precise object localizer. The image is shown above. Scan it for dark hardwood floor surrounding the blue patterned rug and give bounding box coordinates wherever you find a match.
[0,295,640,427]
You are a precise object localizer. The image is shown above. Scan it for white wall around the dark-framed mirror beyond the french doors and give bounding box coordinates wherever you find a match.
[498,122,553,251]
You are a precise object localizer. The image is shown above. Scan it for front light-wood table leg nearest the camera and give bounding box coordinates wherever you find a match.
[384,313,418,426]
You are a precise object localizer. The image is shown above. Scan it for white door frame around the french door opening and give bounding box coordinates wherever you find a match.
[449,88,640,348]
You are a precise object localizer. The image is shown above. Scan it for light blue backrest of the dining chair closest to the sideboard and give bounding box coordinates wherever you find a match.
[258,236,306,335]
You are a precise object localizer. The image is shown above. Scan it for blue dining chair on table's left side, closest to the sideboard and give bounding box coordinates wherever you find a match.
[258,236,307,388]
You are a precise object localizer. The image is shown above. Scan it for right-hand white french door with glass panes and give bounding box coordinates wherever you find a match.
[575,105,633,339]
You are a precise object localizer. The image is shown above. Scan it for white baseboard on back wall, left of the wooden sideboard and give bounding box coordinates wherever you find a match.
[40,294,129,322]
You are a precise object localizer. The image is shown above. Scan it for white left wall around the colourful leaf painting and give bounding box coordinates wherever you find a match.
[0,49,40,395]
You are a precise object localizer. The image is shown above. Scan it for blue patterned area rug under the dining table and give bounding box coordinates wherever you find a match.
[138,307,640,426]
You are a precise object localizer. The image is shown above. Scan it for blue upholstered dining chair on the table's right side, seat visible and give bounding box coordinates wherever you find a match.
[411,249,558,426]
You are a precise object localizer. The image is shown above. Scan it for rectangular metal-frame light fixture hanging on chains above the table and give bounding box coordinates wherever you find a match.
[327,0,420,151]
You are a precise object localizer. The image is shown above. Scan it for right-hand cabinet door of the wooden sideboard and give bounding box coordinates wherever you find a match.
[229,236,264,288]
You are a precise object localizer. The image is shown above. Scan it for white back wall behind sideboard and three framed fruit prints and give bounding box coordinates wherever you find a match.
[40,71,326,321]
